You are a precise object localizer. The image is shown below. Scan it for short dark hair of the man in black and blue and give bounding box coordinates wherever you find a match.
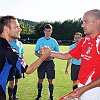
[0,15,16,34]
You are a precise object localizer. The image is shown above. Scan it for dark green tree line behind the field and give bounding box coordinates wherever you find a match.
[18,18,84,40]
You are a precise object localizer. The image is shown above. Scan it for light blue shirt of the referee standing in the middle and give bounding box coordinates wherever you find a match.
[34,37,59,60]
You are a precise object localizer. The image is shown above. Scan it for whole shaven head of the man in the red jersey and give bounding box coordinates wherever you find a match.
[81,9,100,38]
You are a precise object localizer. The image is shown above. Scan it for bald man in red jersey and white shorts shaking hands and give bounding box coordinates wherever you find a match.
[42,9,100,100]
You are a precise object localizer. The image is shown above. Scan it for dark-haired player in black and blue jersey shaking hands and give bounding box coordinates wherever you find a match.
[0,16,50,100]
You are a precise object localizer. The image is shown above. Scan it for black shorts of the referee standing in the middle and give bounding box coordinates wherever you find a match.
[37,60,55,79]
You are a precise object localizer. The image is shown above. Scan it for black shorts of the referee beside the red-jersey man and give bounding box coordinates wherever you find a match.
[71,64,80,81]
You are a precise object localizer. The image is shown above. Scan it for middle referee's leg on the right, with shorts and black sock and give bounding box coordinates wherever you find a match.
[47,61,55,100]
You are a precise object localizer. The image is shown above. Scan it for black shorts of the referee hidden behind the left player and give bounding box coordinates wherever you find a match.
[8,67,22,81]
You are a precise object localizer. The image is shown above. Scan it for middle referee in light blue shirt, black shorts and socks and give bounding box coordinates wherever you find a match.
[35,24,59,100]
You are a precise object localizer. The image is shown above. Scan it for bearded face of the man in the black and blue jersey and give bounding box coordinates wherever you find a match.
[8,19,22,39]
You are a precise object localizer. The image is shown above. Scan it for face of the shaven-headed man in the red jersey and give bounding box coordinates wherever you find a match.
[81,13,96,35]
